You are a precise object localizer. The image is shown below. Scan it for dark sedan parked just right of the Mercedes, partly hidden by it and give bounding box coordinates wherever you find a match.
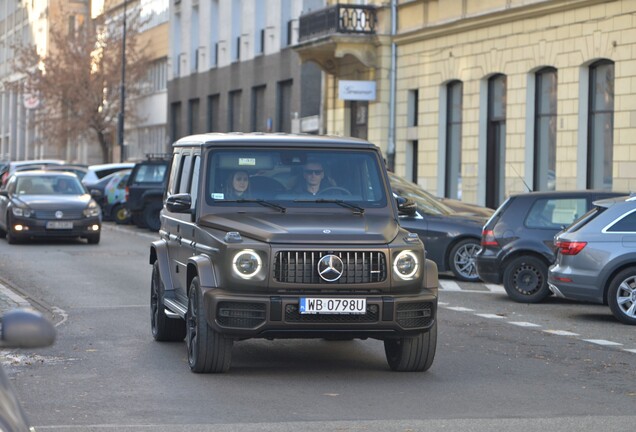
[389,174,487,282]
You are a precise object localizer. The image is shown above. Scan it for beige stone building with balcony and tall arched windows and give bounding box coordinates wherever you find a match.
[297,0,636,207]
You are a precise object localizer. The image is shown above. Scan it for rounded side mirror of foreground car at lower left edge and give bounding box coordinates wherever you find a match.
[0,309,56,348]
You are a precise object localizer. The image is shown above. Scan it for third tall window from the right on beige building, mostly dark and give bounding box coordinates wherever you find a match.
[486,74,506,208]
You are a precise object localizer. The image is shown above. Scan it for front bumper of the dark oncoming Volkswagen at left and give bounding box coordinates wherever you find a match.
[9,216,102,238]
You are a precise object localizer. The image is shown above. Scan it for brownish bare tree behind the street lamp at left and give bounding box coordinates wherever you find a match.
[15,10,149,162]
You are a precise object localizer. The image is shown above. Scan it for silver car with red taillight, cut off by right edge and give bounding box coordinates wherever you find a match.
[548,196,636,325]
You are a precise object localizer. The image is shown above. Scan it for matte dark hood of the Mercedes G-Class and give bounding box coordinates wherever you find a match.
[200,211,399,245]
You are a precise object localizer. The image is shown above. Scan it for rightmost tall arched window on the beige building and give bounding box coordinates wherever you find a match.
[587,60,614,190]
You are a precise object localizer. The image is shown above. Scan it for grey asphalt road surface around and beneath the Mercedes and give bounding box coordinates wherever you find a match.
[0,225,636,432]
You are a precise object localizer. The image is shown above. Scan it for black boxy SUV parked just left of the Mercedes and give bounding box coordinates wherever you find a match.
[125,154,171,231]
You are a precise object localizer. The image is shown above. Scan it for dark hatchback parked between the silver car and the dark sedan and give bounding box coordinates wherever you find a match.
[475,190,626,303]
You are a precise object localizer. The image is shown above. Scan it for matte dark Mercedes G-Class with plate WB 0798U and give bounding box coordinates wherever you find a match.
[150,133,438,372]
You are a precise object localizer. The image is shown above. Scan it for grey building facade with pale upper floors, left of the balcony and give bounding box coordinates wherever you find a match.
[168,0,324,141]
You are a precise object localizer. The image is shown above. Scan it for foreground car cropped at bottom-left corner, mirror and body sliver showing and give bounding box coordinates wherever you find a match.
[0,309,56,432]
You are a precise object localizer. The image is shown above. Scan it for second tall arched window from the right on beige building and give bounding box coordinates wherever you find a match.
[533,67,557,190]
